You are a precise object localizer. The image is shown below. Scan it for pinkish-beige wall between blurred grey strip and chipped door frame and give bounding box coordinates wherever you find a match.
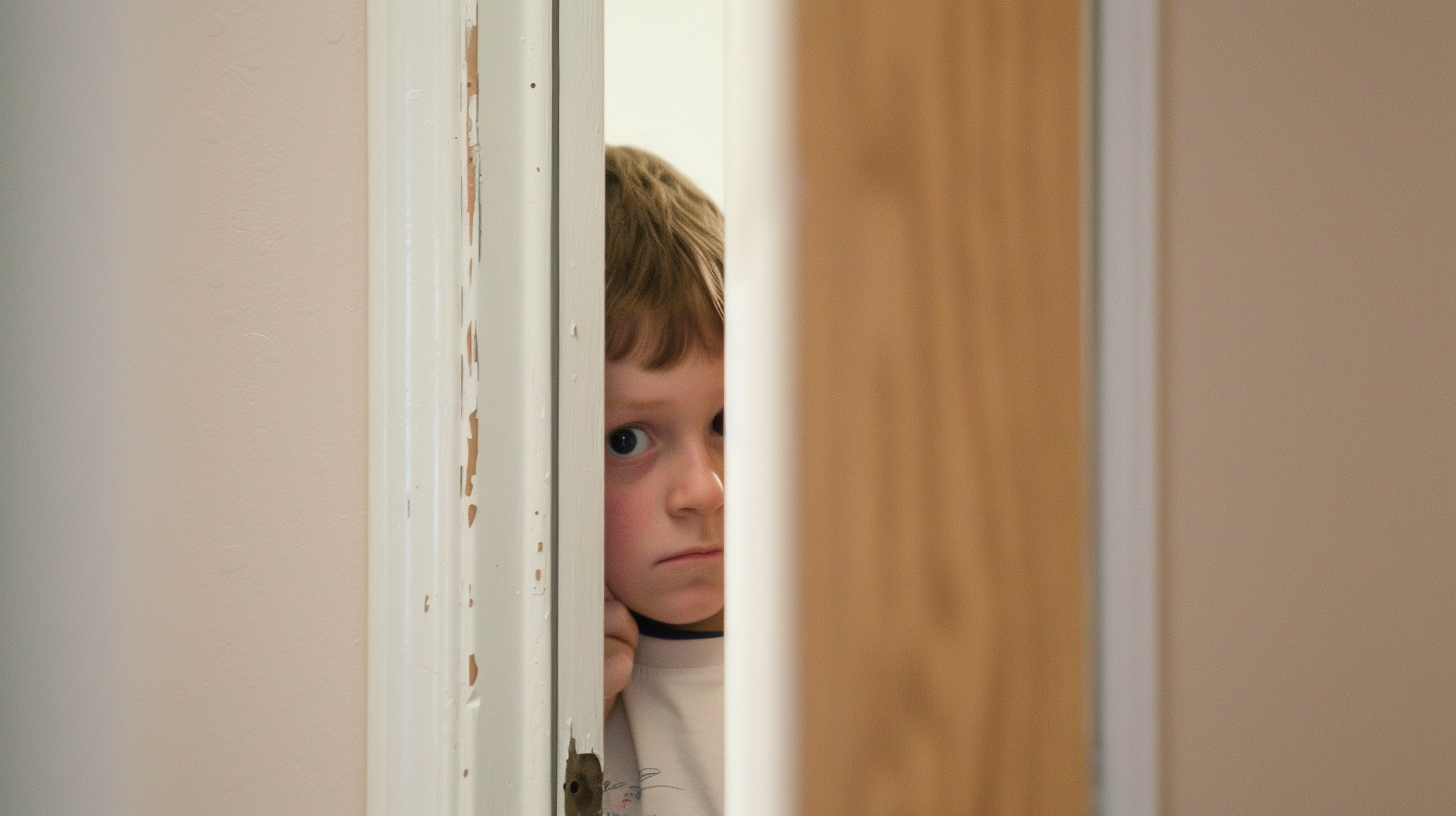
[127,0,367,815]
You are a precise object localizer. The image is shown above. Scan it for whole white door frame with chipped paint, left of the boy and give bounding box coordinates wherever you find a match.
[367,0,603,816]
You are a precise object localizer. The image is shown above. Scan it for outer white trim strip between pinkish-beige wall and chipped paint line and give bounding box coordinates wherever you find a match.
[367,0,473,816]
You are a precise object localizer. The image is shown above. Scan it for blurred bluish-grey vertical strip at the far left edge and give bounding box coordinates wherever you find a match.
[0,0,125,816]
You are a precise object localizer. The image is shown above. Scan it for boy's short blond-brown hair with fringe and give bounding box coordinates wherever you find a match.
[606,146,724,370]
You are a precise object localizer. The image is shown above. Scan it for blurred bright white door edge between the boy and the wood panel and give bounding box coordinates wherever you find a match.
[724,0,799,816]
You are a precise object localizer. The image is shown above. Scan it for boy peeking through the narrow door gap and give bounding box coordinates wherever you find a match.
[603,147,724,816]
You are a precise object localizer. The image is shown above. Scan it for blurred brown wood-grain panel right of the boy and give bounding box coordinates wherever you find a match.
[796,0,1089,816]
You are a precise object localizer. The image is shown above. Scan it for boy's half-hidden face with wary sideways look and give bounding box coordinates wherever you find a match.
[606,354,724,629]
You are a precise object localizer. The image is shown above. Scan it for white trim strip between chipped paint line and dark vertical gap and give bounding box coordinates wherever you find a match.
[466,0,556,816]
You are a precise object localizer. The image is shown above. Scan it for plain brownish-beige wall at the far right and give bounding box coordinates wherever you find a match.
[1163,0,1456,816]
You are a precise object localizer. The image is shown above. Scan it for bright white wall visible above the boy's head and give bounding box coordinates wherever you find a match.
[606,0,724,207]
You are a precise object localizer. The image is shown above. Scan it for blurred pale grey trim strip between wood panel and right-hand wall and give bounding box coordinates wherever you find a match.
[1093,0,1159,816]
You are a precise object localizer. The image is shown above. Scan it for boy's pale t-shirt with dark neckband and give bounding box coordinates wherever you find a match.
[601,635,724,816]
